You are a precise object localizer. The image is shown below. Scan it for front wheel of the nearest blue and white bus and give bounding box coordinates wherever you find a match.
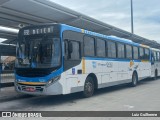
[83,76,94,98]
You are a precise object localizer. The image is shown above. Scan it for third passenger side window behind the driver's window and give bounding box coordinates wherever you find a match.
[107,41,116,58]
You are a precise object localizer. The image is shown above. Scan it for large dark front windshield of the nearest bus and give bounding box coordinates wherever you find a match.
[16,37,61,68]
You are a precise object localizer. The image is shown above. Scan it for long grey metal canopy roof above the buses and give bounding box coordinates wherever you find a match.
[0,0,160,48]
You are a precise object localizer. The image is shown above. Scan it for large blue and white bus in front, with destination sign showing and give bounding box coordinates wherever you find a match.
[15,24,151,97]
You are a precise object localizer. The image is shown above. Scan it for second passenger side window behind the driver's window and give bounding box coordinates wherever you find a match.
[96,39,106,57]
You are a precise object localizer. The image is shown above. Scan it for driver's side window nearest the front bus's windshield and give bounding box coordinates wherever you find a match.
[65,40,80,60]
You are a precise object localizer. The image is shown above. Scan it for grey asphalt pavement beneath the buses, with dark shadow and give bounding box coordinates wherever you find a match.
[0,79,160,120]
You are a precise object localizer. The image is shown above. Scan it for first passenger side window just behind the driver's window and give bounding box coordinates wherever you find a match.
[84,36,95,56]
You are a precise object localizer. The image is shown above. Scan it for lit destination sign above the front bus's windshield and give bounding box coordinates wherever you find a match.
[23,26,53,35]
